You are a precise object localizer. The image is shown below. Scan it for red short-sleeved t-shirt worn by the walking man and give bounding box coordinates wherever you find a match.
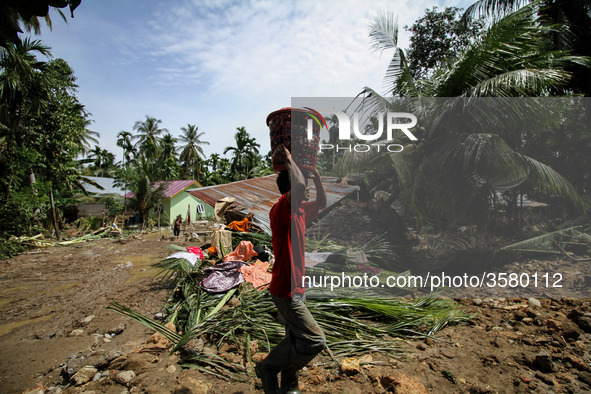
[269,194,319,298]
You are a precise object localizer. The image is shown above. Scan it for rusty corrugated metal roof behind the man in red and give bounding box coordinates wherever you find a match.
[188,175,358,234]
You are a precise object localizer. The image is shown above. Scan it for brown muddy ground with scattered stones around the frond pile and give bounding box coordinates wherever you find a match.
[0,233,591,393]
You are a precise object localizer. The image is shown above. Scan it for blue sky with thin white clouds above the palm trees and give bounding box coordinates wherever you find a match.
[35,0,472,159]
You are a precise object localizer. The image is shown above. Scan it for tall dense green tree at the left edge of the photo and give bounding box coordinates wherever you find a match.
[0,39,92,238]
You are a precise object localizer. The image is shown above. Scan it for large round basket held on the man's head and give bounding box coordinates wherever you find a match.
[267,107,320,172]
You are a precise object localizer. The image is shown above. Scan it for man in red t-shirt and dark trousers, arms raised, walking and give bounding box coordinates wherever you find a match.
[255,144,326,394]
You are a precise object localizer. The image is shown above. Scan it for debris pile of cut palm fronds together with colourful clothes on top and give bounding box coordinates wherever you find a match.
[109,226,466,382]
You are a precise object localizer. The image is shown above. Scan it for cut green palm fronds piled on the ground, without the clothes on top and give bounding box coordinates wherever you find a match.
[109,237,465,381]
